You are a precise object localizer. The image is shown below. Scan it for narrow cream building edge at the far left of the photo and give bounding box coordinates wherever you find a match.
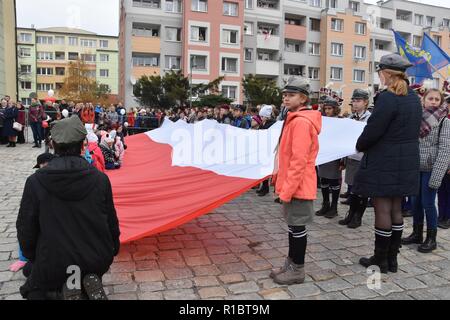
[0,0,17,100]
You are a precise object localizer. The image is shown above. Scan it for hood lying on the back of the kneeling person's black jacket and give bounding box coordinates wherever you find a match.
[35,156,99,201]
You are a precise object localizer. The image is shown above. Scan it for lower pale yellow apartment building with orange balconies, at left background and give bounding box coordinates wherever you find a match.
[17,28,119,105]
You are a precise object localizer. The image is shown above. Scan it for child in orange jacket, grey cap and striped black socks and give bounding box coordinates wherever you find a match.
[270,78,322,285]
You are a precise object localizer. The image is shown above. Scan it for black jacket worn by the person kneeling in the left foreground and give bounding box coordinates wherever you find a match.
[16,157,120,290]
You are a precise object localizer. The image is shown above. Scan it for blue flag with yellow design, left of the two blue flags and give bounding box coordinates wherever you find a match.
[392,30,433,83]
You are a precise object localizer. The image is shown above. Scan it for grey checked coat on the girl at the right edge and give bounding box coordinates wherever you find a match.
[419,117,450,190]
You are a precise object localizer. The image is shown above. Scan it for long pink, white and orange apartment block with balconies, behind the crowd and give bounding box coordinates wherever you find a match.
[119,0,450,109]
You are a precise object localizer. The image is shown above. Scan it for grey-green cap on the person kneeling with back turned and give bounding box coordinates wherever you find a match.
[50,116,87,144]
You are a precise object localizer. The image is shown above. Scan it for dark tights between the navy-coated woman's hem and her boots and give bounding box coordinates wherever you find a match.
[372,197,403,230]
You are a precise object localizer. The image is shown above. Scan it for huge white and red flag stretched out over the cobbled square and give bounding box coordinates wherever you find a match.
[108,118,364,243]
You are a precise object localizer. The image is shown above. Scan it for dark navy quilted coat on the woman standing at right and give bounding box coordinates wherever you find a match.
[353,89,422,197]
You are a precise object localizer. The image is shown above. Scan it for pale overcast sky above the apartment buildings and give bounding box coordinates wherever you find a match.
[16,0,450,36]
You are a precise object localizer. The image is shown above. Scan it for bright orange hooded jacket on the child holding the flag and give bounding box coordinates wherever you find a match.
[273,108,322,202]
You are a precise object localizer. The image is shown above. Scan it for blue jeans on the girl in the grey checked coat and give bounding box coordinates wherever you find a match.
[411,172,438,230]
